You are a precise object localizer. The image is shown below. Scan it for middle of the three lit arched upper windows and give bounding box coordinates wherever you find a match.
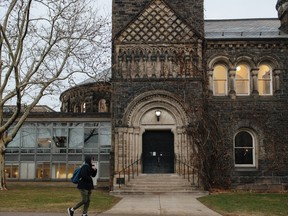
[235,64,250,95]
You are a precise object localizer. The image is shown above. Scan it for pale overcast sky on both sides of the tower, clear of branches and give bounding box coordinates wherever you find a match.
[98,0,277,19]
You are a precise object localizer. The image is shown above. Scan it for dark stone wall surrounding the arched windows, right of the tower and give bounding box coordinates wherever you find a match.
[206,39,288,190]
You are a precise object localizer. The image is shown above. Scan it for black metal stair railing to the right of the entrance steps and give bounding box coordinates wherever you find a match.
[175,155,200,187]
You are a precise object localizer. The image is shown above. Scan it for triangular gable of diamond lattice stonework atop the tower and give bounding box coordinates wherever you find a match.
[119,0,195,43]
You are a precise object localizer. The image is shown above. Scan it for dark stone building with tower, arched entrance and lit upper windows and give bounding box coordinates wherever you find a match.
[111,0,288,190]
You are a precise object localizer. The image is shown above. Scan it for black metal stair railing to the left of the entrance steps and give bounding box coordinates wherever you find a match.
[118,157,142,188]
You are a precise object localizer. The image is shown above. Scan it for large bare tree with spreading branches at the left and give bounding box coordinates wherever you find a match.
[0,0,110,189]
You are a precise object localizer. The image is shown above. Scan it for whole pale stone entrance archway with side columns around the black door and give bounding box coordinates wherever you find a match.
[114,90,192,173]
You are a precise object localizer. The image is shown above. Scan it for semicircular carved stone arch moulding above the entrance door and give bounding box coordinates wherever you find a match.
[123,90,189,127]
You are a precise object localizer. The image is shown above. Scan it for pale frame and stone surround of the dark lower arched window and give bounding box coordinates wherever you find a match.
[233,128,257,168]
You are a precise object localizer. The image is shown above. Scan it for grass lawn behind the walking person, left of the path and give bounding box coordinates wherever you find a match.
[0,183,120,213]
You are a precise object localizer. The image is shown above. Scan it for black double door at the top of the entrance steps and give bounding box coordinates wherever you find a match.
[142,130,174,173]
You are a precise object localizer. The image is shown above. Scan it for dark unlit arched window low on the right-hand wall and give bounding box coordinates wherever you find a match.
[234,130,256,167]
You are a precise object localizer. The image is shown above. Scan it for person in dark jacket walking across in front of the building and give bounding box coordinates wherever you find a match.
[68,156,97,216]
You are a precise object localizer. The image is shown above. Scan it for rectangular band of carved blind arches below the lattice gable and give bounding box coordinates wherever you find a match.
[116,45,202,79]
